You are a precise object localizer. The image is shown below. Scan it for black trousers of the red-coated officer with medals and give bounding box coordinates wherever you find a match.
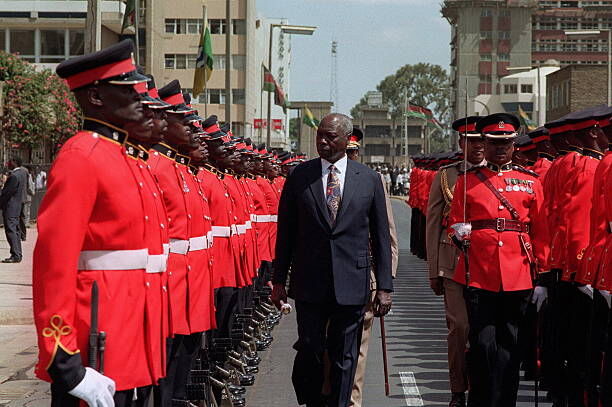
[465,287,531,407]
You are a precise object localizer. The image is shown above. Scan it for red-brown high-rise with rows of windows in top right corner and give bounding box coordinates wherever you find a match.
[532,0,612,66]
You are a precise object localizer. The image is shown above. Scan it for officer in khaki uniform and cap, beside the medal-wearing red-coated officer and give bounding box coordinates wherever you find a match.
[426,116,486,407]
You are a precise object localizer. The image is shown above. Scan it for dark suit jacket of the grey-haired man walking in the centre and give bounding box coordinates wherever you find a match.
[272,158,393,305]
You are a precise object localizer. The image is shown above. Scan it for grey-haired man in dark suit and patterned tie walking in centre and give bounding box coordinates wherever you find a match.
[272,114,393,407]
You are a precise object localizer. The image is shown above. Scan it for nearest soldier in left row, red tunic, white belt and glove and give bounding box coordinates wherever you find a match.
[33,41,167,407]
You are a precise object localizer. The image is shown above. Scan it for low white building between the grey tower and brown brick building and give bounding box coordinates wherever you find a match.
[464,61,559,125]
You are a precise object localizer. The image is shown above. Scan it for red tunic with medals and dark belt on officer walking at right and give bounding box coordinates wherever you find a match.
[449,166,547,292]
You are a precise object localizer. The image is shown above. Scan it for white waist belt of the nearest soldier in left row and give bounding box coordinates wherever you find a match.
[78,249,149,270]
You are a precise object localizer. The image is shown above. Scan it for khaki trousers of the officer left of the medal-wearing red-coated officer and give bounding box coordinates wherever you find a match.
[444,278,470,393]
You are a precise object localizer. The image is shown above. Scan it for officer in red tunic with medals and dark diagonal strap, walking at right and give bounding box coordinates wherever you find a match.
[449,113,547,406]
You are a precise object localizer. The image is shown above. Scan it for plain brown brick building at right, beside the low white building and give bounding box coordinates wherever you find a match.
[546,64,608,121]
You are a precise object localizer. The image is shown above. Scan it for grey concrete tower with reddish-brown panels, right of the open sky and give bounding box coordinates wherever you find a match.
[441,0,537,117]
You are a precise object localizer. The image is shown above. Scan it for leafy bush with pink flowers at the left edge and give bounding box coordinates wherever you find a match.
[0,52,81,160]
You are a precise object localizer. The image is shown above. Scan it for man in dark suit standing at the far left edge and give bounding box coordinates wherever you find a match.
[0,157,28,263]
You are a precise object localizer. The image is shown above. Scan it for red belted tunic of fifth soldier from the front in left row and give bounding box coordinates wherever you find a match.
[198,165,238,288]
